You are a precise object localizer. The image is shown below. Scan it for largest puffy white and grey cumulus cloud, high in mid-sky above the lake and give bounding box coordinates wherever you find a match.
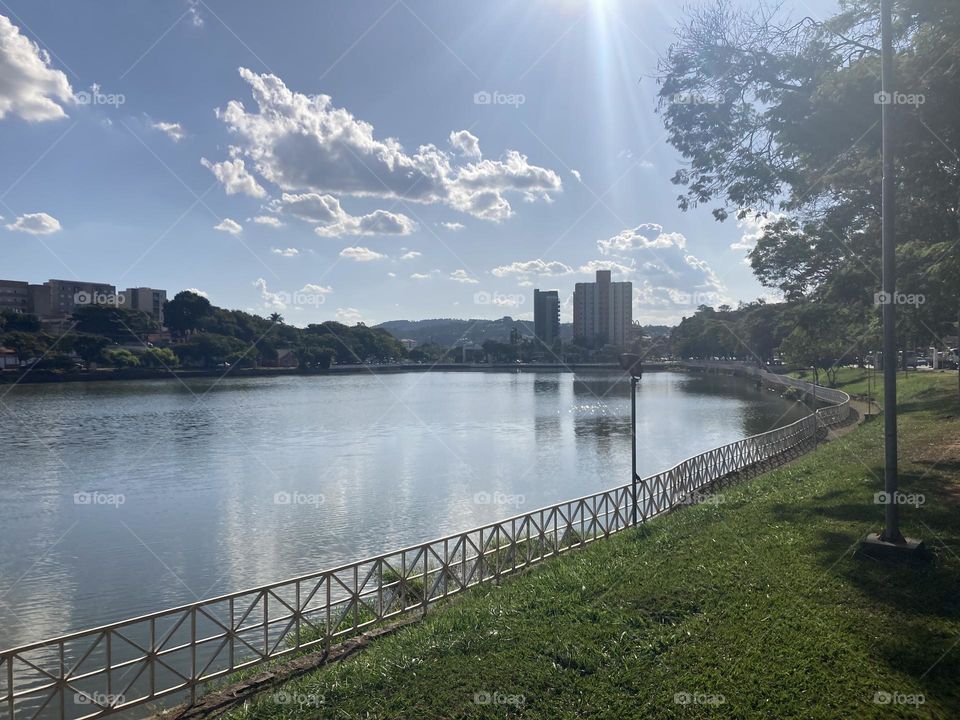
[217,68,562,221]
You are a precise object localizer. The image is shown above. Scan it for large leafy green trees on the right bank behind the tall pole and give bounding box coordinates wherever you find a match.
[659,0,960,362]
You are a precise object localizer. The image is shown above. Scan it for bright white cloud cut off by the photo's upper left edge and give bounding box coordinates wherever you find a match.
[0,15,74,122]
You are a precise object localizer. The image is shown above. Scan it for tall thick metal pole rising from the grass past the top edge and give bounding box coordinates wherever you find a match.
[880,0,905,543]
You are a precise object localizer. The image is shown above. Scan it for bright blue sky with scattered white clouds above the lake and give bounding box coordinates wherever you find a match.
[0,0,835,326]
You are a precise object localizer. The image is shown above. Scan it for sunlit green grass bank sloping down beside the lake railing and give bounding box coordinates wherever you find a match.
[225,371,960,720]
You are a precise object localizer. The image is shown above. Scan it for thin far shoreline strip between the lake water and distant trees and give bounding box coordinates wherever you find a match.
[0,362,679,385]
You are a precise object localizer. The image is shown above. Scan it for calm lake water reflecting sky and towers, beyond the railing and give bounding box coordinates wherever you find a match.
[0,373,805,647]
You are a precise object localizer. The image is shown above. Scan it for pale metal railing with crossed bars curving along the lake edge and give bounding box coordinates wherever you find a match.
[0,368,849,720]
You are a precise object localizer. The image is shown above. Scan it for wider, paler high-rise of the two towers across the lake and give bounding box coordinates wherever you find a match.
[573,270,633,346]
